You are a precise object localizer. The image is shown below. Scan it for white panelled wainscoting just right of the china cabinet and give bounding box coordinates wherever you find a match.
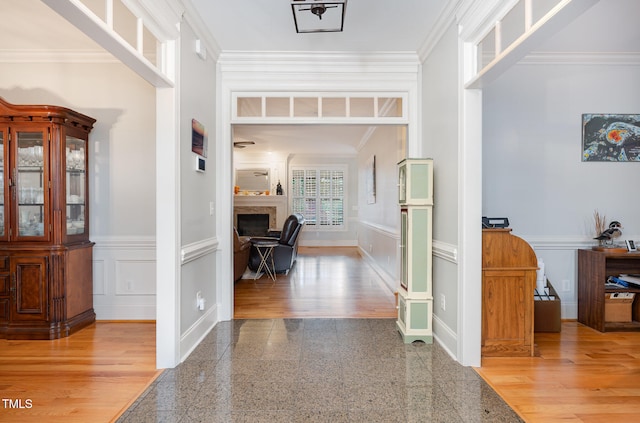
[92,237,156,320]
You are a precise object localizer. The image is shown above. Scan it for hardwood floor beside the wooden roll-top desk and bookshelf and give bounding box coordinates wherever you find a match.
[476,321,640,423]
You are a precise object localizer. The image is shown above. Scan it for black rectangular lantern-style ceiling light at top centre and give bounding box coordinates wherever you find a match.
[291,0,347,33]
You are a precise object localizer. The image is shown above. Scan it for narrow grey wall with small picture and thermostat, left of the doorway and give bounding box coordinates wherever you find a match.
[178,22,220,358]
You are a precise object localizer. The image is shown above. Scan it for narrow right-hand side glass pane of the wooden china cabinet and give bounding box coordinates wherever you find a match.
[65,136,87,235]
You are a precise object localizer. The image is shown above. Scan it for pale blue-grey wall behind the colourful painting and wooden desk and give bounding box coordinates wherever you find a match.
[482,64,640,319]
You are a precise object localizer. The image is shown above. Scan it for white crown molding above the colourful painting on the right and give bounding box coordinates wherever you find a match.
[518,51,640,66]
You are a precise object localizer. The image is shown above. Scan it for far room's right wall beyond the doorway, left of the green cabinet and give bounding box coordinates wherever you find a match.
[358,126,405,292]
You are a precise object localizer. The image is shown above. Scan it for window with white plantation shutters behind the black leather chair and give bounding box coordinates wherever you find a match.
[291,168,346,230]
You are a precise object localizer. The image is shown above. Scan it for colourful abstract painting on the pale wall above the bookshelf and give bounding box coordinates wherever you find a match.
[582,113,640,162]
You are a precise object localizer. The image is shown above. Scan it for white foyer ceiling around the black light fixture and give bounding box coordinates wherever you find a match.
[191,0,447,52]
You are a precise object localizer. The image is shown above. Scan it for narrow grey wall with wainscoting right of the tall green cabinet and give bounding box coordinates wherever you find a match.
[422,24,459,354]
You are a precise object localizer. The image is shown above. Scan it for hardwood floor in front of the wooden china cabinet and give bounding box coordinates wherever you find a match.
[0,322,161,423]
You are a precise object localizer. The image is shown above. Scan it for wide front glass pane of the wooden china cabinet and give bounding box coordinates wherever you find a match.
[14,130,46,237]
